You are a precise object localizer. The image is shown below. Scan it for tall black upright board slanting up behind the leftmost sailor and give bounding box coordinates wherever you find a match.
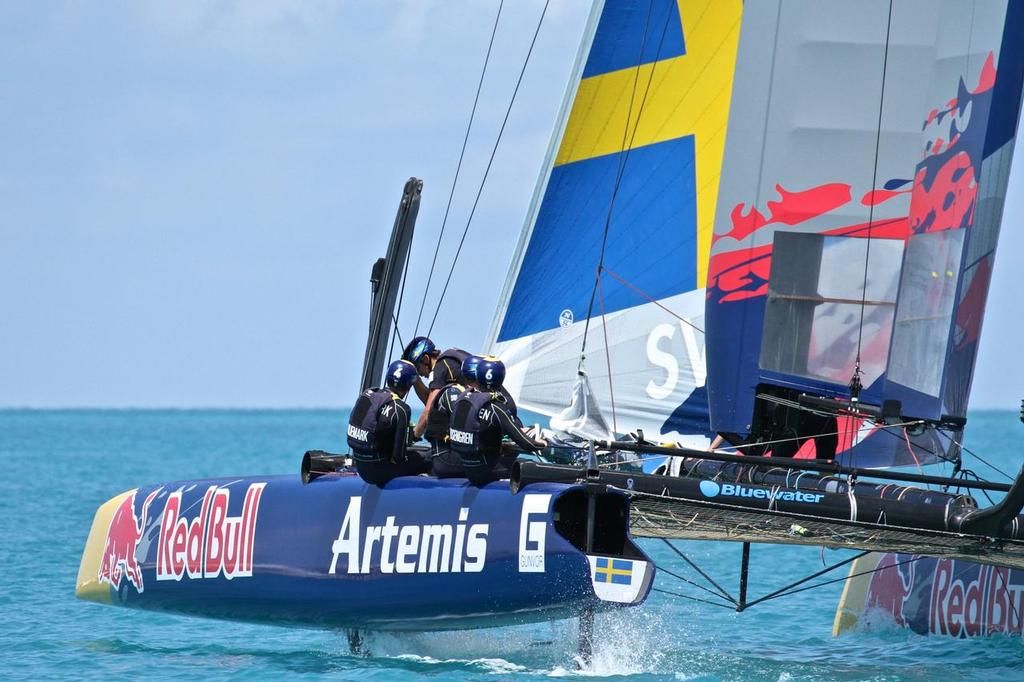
[359,177,423,391]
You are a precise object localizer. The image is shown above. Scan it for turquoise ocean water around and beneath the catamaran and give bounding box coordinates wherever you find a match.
[0,411,1024,682]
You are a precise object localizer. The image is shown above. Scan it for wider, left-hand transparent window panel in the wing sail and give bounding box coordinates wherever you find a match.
[761,231,903,386]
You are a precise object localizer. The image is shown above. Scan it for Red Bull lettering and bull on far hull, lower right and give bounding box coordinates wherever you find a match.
[865,554,1024,638]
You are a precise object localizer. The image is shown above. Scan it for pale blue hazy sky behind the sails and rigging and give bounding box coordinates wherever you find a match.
[0,0,1024,409]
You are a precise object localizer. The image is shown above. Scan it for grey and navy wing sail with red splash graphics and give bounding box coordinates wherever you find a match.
[707,0,1024,466]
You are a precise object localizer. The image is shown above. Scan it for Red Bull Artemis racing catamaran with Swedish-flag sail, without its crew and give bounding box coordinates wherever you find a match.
[76,0,1024,643]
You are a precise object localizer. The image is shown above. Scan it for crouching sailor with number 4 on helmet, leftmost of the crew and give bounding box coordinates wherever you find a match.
[348,360,430,486]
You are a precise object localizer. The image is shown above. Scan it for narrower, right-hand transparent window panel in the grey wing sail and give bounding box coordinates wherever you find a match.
[889,229,965,397]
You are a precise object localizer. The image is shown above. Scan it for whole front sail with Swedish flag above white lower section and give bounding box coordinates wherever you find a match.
[487,0,742,445]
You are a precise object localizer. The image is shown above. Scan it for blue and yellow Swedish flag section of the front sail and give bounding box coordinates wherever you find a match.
[497,0,742,341]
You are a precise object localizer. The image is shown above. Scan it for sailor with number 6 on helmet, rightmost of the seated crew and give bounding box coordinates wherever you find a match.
[449,357,548,485]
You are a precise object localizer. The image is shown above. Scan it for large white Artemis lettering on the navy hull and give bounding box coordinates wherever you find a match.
[328,497,490,576]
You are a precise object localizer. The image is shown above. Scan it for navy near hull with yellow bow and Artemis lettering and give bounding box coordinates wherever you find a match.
[76,475,653,631]
